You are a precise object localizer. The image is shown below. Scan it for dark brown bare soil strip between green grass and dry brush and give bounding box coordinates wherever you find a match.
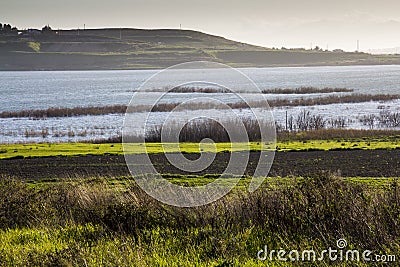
[0,149,400,180]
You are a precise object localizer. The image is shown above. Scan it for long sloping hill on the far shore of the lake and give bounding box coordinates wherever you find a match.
[0,28,400,70]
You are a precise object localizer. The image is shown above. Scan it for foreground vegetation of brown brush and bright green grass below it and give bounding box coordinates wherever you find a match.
[0,174,400,266]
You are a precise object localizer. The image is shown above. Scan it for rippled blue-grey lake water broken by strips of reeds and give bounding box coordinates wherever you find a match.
[0,66,400,143]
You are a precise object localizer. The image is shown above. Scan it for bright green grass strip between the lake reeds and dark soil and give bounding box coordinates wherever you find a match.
[0,137,400,159]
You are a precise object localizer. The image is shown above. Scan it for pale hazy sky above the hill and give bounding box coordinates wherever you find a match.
[0,0,400,51]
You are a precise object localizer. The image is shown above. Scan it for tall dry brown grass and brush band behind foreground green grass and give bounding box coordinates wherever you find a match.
[0,173,400,250]
